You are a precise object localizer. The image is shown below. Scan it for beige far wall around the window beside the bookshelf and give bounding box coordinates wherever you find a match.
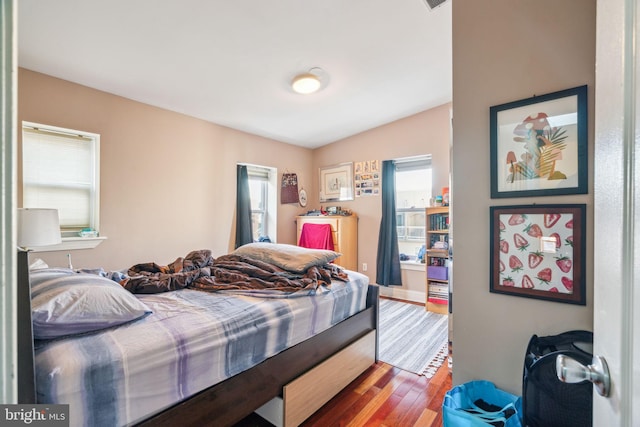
[309,104,451,296]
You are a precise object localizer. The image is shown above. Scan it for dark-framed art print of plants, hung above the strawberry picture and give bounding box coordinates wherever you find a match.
[489,86,588,199]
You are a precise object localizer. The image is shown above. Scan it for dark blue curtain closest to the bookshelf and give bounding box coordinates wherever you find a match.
[376,160,402,286]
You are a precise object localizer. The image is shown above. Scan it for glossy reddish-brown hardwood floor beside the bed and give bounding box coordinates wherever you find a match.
[235,361,451,427]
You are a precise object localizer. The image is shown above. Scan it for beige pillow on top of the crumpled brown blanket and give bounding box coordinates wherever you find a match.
[233,243,341,273]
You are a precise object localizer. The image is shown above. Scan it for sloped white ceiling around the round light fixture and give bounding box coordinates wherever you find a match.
[18,0,452,148]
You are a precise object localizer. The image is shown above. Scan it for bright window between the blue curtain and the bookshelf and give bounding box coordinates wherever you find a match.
[396,155,432,261]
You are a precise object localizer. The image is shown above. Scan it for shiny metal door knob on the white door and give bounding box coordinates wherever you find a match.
[556,354,611,397]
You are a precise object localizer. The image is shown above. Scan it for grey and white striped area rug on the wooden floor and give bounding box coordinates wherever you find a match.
[379,298,449,377]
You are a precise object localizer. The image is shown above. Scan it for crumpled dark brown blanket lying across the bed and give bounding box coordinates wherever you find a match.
[123,249,348,294]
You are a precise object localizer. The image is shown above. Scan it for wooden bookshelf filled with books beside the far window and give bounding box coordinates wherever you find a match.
[425,206,449,314]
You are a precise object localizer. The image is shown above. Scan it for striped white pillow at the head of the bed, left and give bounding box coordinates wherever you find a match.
[30,268,151,339]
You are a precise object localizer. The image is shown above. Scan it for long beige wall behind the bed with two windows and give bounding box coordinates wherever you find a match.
[18,69,313,269]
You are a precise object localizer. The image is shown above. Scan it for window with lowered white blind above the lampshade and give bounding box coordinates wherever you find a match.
[22,122,100,237]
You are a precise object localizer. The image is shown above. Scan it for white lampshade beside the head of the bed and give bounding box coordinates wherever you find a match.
[18,208,62,248]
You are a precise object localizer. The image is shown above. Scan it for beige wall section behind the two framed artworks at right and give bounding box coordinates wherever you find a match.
[452,0,596,394]
